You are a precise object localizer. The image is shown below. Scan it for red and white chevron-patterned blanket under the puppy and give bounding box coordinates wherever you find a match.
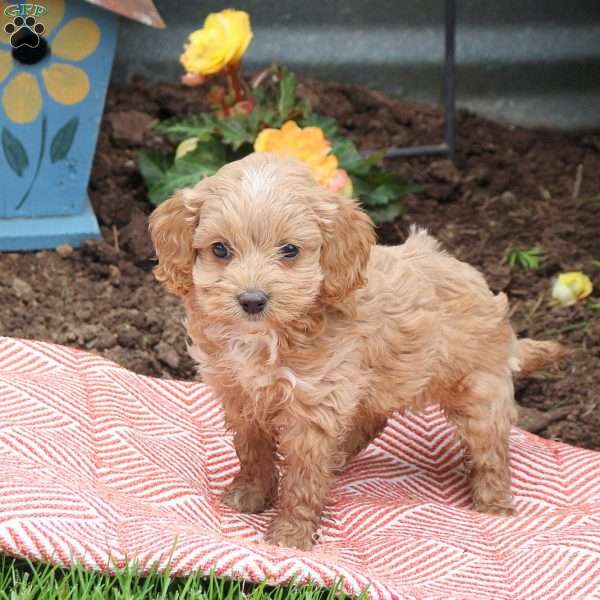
[0,338,600,600]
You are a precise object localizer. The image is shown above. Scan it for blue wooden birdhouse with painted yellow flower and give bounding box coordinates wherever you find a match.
[0,0,164,250]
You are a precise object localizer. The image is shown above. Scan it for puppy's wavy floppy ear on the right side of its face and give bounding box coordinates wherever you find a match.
[315,190,375,304]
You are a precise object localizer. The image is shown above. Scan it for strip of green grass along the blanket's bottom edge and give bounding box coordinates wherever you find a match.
[0,556,367,600]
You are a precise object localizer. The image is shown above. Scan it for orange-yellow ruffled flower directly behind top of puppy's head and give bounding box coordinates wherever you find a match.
[254,121,338,186]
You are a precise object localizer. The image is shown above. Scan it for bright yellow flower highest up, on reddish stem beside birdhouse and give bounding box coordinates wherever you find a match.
[180,8,252,75]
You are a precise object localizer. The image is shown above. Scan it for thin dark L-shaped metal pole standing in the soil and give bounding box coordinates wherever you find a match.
[385,0,456,160]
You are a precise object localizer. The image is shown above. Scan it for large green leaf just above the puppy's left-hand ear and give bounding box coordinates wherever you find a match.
[148,140,227,206]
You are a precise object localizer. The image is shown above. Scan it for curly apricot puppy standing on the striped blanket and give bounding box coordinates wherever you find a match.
[150,154,564,550]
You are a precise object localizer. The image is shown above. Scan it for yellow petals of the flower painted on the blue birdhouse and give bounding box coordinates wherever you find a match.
[0,0,100,123]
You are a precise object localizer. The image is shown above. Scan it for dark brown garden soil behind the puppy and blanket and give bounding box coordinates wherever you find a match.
[0,80,600,449]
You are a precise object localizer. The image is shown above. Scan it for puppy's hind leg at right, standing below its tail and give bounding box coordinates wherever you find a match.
[442,369,517,515]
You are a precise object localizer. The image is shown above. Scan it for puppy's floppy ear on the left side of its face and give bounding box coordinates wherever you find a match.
[150,189,201,298]
